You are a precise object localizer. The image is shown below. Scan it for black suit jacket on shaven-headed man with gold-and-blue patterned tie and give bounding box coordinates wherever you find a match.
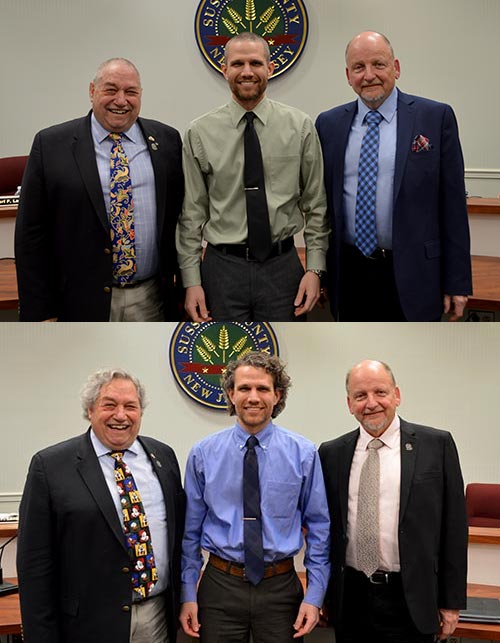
[15,113,184,321]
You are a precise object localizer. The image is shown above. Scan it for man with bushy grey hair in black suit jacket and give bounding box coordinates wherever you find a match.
[17,370,185,643]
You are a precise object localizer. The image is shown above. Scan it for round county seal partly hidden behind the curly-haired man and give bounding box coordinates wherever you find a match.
[169,322,279,410]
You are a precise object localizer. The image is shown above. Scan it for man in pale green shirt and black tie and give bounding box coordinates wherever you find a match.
[177,33,329,322]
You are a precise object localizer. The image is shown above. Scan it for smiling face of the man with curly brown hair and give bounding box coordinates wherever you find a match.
[228,366,281,434]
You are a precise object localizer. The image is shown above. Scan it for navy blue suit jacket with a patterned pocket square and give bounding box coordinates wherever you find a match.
[316,91,472,321]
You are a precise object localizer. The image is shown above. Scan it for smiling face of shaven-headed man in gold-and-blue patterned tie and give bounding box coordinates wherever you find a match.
[89,60,142,132]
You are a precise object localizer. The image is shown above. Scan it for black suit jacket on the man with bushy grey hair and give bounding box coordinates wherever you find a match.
[17,432,185,643]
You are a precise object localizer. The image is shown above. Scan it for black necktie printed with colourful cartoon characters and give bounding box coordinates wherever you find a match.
[109,451,158,600]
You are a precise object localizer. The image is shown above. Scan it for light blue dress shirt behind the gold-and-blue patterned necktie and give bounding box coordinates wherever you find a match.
[91,114,159,281]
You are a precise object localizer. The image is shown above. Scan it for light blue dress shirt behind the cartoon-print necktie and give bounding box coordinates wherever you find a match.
[90,429,169,596]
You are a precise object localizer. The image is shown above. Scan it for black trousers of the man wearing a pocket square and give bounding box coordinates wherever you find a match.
[339,243,406,322]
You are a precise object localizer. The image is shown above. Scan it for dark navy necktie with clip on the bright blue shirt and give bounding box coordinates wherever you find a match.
[243,435,264,585]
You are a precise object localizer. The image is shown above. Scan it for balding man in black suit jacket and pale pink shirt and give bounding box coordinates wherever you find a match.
[319,360,467,643]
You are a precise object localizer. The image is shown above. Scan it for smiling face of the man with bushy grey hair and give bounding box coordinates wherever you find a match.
[88,377,142,451]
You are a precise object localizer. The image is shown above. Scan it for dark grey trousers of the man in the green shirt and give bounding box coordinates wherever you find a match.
[201,245,304,321]
